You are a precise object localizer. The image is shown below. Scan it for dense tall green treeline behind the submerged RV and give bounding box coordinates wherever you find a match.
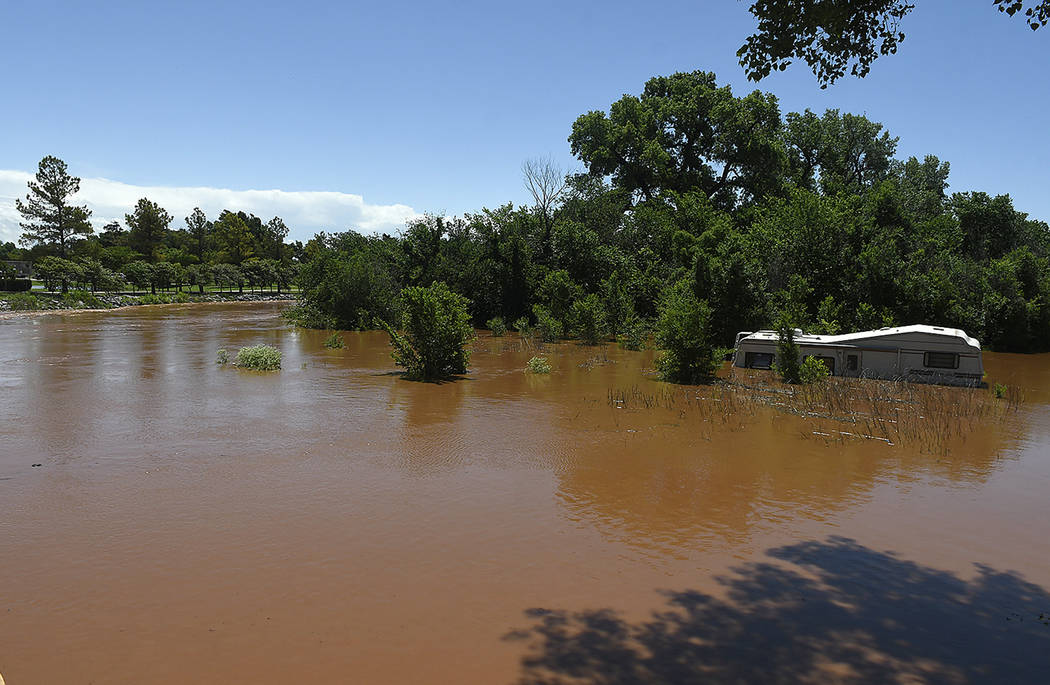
[298,71,1050,351]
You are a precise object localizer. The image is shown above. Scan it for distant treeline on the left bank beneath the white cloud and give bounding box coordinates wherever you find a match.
[7,157,302,292]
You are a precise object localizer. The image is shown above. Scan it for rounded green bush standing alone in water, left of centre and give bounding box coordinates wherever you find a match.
[377,281,474,380]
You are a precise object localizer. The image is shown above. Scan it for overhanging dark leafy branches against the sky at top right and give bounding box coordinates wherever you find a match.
[736,0,1050,88]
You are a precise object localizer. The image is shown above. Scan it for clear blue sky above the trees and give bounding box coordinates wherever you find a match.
[0,0,1050,240]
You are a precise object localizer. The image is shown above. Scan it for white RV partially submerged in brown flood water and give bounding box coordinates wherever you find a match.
[733,325,984,386]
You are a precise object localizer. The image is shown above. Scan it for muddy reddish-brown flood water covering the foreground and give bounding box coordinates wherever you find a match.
[0,303,1050,685]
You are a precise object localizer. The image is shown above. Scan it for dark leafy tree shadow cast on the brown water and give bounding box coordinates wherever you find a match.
[505,538,1050,685]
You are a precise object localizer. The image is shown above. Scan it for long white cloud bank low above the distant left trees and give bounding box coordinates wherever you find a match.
[0,169,419,242]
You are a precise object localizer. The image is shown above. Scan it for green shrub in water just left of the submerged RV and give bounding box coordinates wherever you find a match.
[656,279,718,383]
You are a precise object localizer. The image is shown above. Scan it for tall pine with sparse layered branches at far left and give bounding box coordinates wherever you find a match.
[15,155,93,262]
